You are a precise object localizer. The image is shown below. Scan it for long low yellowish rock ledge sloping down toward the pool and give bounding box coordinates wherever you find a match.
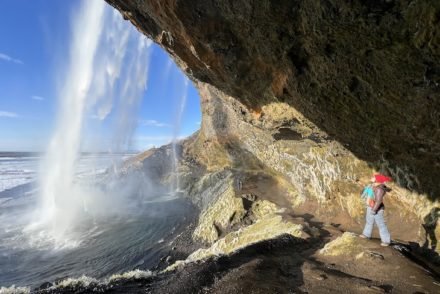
[187,215,303,261]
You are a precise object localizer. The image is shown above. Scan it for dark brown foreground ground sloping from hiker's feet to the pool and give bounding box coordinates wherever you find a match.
[33,216,440,293]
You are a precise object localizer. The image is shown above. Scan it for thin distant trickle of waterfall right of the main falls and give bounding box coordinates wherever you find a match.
[171,77,189,193]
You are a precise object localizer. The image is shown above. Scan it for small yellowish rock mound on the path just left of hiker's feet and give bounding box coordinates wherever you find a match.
[319,232,363,256]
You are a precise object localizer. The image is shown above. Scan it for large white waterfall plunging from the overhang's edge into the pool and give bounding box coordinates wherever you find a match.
[33,1,151,246]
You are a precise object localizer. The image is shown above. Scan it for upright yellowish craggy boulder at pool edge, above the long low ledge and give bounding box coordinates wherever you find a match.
[193,181,246,244]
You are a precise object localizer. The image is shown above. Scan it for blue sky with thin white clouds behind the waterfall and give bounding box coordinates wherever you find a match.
[0,0,201,151]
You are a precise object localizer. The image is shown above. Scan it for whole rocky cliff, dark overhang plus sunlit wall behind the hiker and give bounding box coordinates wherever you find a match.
[100,0,440,289]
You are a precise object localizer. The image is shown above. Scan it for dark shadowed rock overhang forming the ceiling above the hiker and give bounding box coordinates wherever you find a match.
[106,0,440,199]
